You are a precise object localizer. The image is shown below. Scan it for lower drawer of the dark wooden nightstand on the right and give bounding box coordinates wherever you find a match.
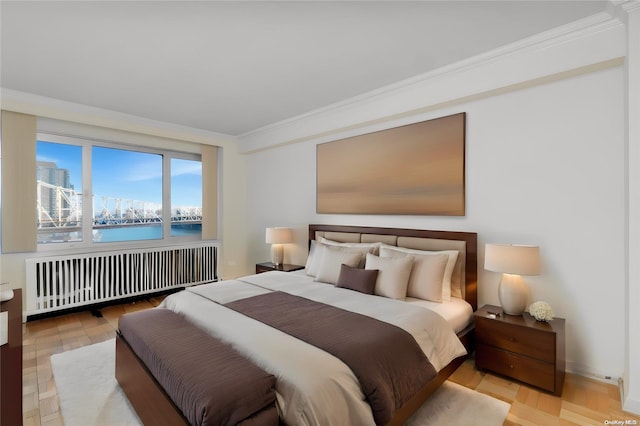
[476,343,556,392]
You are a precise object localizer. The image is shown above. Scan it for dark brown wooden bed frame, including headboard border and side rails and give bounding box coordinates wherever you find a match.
[116,225,478,426]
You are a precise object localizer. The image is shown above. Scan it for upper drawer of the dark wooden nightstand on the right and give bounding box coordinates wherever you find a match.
[476,318,556,363]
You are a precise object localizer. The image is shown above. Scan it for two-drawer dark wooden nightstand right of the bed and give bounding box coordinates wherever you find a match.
[474,305,565,396]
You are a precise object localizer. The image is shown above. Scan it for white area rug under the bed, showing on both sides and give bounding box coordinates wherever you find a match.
[51,340,509,426]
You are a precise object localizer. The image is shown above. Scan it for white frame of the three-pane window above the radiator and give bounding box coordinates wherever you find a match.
[34,131,203,252]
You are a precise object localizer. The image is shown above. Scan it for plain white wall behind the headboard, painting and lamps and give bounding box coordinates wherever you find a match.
[247,67,625,377]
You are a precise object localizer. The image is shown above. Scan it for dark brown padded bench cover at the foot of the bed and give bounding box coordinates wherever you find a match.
[119,308,278,425]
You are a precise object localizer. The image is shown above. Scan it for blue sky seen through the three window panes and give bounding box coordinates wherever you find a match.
[37,141,202,211]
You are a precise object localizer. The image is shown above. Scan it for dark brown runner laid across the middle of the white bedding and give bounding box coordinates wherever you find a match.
[225,291,436,425]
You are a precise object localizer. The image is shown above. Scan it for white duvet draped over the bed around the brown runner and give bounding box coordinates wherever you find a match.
[161,272,466,425]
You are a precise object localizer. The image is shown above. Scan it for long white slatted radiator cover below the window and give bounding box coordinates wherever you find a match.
[25,244,218,316]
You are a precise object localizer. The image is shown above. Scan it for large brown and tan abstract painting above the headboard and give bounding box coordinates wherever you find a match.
[316,113,466,216]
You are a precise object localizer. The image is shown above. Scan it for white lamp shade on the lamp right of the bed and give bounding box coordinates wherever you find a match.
[484,244,540,275]
